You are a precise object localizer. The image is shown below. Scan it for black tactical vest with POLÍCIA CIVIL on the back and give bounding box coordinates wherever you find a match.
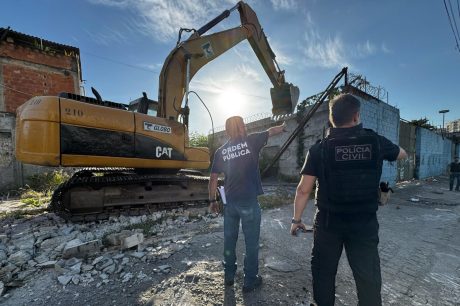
[318,129,382,213]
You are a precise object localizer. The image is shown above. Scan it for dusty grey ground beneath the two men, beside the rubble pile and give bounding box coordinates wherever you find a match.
[0,177,460,305]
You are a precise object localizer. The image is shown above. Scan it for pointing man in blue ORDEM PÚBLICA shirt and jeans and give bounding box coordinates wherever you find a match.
[209,116,285,292]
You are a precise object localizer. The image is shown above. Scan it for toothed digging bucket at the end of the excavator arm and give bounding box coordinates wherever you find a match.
[270,83,300,116]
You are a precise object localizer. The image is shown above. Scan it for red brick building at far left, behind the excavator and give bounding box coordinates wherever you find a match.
[0,28,82,192]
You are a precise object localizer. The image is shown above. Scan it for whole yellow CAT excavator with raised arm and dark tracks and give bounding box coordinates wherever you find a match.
[16,1,299,220]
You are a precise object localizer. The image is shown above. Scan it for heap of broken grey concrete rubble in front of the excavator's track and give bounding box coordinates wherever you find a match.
[0,208,209,296]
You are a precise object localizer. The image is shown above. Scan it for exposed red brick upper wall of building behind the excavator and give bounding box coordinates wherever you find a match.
[0,42,80,113]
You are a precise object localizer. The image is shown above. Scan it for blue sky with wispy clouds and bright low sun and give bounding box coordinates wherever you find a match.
[0,0,460,133]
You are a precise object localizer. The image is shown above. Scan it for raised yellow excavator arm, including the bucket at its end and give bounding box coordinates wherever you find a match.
[158,1,299,125]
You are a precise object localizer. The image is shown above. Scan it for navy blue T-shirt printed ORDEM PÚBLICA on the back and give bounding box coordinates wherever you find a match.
[211,131,268,203]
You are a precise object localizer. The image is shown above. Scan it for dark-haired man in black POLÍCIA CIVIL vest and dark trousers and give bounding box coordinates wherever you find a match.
[291,94,407,306]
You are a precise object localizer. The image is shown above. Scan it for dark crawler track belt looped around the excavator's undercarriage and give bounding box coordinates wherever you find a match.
[48,168,209,222]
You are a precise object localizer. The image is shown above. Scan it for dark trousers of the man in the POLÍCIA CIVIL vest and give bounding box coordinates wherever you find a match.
[311,211,382,306]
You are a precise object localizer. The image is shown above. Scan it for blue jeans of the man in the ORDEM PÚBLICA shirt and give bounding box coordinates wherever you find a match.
[224,200,261,286]
